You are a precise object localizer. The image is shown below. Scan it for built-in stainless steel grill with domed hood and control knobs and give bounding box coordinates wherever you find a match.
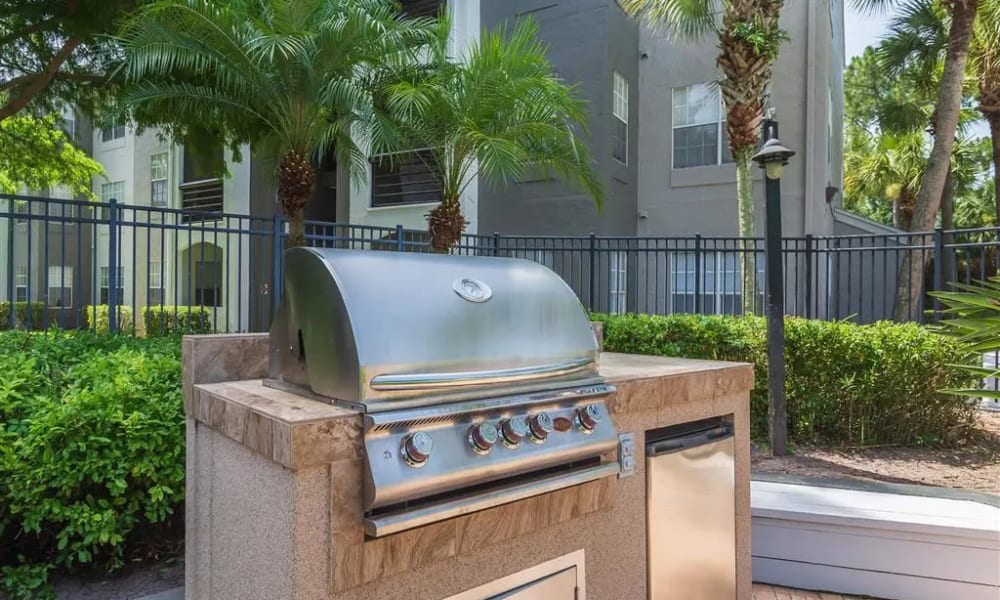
[268,248,618,537]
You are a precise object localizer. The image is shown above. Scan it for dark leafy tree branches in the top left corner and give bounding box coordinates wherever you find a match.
[0,0,135,121]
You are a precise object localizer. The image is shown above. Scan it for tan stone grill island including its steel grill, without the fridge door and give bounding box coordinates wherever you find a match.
[184,249,753,600]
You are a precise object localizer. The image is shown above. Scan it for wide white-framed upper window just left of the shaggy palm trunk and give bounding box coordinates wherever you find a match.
[673,84,733,169]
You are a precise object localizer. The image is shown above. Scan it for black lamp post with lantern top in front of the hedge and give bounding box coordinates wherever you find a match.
[753,122,795,456]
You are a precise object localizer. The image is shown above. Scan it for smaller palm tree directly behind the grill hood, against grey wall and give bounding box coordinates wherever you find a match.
[373,19,604,252]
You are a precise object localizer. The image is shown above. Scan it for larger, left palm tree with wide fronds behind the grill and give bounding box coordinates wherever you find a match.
[118,0,438,245]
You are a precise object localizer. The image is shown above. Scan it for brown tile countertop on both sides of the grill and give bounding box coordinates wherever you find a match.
[185,352,753,470]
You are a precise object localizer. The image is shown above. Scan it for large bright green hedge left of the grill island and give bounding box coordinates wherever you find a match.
[0,331,184,599]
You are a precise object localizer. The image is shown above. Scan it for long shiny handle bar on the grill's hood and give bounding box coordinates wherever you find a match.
[371,358,594,390]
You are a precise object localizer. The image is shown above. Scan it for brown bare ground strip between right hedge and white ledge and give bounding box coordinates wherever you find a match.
[751,412,1000,495]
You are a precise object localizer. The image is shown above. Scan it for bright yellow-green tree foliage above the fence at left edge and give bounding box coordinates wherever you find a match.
[0,115,104,198]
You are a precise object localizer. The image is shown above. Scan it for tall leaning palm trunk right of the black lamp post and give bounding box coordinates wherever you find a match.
[894,0,979,322]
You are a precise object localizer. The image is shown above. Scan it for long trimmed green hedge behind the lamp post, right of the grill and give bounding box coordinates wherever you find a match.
[593,314,975,446]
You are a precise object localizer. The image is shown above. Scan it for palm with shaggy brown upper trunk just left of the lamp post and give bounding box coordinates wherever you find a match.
[619,0,788,313]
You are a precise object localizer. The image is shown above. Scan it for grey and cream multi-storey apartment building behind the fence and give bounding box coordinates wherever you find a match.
[0,0,856,330]
